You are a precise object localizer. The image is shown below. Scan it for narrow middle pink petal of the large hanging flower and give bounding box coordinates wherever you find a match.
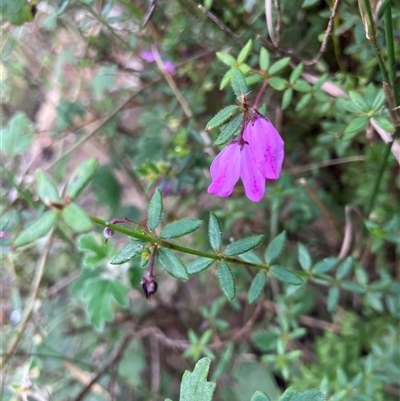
[240,144,265,202]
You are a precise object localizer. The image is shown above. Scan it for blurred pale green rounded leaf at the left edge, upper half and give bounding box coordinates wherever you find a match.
[0,112,34,156]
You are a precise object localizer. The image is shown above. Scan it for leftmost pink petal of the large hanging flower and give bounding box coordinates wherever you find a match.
[207,142,240,197]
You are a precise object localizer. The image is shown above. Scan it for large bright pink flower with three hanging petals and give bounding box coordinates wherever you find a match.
[207,116,284,202]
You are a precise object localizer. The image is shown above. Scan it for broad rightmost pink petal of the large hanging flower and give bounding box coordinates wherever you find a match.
[244,117,284,180]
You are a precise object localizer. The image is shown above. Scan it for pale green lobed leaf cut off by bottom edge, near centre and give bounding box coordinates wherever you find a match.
[179,358,215,401]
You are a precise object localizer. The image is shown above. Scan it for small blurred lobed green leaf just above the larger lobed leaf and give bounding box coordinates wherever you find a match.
[78,233,113,269]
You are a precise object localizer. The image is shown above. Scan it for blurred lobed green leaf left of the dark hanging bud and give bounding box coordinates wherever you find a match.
[82,277,128,330]
